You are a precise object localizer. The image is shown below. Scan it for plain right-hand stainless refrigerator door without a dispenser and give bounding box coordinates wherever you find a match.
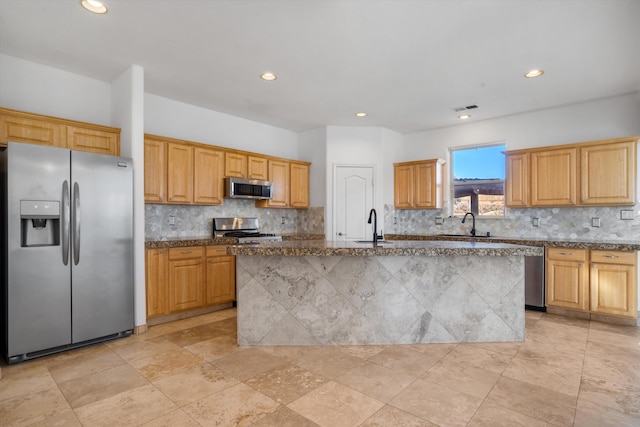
[70,151,134,343]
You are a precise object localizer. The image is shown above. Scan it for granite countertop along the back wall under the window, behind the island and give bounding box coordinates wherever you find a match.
[386,234,640,251]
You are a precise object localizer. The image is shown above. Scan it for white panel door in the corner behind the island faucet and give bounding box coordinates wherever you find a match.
[333,166,381,240]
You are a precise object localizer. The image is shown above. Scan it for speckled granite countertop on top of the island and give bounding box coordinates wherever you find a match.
[227,240,544,256]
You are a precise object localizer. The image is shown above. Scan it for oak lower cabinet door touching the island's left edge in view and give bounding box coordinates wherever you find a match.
[205,255,236,304]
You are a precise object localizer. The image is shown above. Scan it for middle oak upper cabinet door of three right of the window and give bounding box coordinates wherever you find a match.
[531,148,577,206]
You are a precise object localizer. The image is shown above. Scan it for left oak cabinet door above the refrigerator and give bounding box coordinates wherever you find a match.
[0,115,67,147]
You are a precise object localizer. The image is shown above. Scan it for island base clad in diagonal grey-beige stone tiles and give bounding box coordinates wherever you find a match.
[236,256,524,346]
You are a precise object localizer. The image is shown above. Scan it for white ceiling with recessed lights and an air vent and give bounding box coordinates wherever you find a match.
[0,0,640,133]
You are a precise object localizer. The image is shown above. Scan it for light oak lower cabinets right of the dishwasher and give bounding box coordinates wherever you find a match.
[546,248,638,319]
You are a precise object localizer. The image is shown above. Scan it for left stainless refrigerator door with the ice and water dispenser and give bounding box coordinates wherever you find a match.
[3,143,71,357]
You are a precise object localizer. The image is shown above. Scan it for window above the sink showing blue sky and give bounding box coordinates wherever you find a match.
[451,144,506,218]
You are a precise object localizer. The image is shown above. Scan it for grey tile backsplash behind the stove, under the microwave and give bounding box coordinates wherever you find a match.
[145,199,324,239]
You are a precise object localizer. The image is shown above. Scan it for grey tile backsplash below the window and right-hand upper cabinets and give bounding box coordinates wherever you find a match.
[384,204,640,241]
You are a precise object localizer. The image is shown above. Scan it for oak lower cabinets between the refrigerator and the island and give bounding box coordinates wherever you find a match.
[146,246,236,317]
